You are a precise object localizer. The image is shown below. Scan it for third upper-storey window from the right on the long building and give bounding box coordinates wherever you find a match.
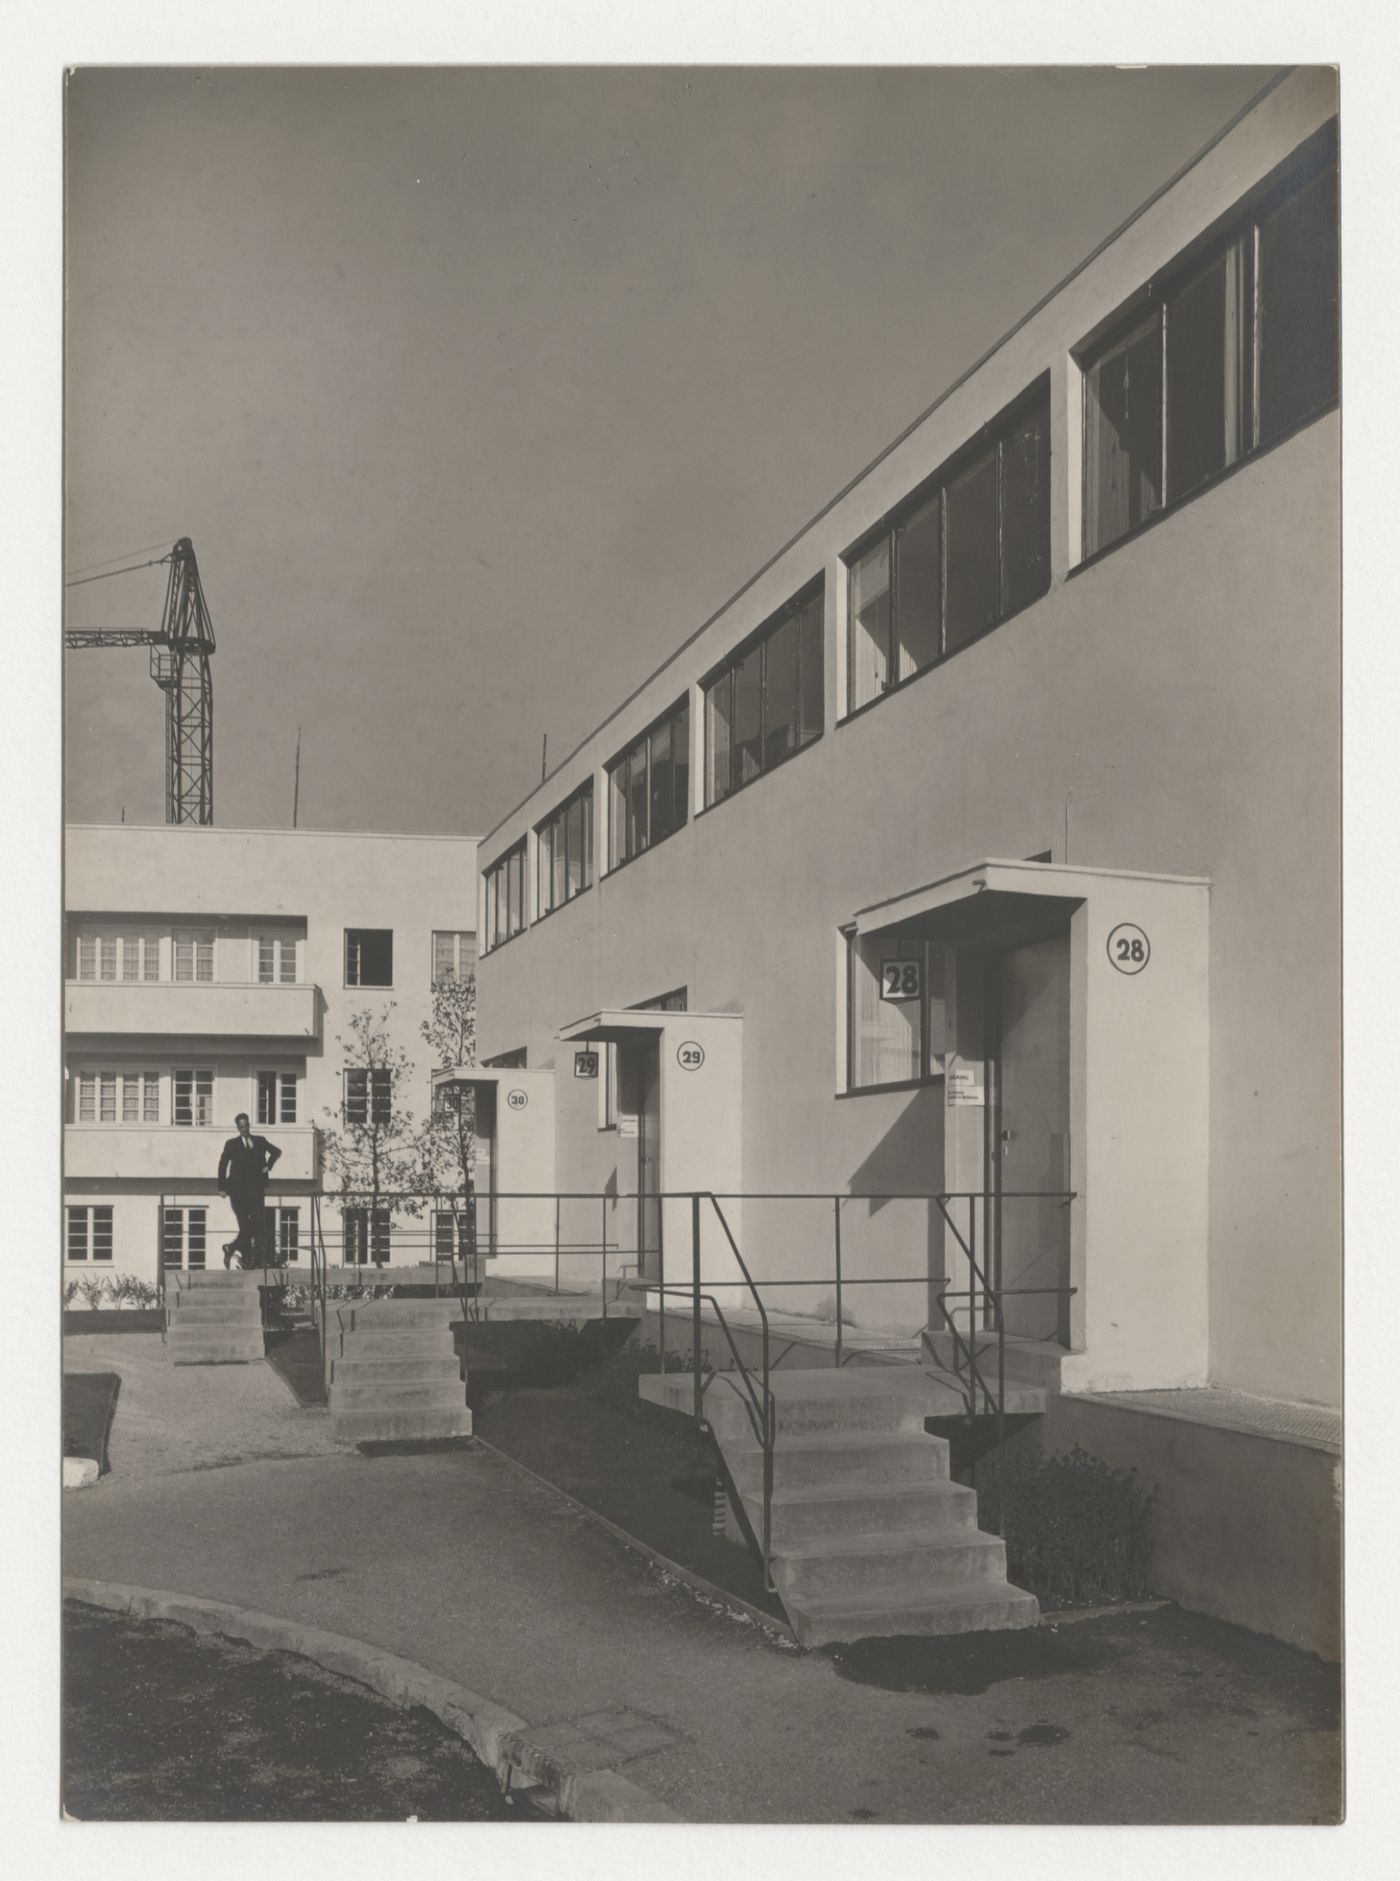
[704,581,824,805]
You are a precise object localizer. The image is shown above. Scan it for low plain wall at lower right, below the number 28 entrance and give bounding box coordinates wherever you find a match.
[1009,1398,1342,1659]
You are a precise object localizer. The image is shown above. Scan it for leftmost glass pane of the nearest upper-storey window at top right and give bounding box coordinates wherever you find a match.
[1084,308,1161,555]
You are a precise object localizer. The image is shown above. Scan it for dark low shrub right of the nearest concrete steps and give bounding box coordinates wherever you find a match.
[978,1445,1157,1606]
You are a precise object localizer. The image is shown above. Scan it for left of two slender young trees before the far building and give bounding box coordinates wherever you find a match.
[322,1001,423,1257]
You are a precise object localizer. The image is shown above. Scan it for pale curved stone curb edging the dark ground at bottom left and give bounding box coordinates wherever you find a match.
[62,1578,685,1823]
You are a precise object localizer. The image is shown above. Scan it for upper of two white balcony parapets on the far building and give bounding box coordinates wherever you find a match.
[64,980,320,1044]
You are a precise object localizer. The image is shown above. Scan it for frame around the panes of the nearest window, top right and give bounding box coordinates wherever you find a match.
[1069,119,1342,576]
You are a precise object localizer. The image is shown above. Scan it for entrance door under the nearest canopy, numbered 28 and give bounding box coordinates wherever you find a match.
[988,935,1069,1343]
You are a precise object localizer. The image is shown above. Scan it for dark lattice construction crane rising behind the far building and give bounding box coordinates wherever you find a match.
[64,536,215,824]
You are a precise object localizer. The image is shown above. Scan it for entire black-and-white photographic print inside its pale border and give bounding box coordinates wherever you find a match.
[5,11,1381,1850]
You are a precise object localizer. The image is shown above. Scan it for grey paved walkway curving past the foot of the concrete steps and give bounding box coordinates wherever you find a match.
[64,1339,1338,1823]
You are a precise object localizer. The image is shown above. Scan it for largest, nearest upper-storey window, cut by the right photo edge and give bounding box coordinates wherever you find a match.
[1080,130,1338,555]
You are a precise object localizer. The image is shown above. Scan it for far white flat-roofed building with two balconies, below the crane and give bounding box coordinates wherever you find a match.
[64,824,476,1281]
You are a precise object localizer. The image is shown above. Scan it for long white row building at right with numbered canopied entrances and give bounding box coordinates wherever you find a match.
[480,70,1340,1648]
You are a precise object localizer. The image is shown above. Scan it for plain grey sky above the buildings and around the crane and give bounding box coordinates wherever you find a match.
[64,66,1272,835]
